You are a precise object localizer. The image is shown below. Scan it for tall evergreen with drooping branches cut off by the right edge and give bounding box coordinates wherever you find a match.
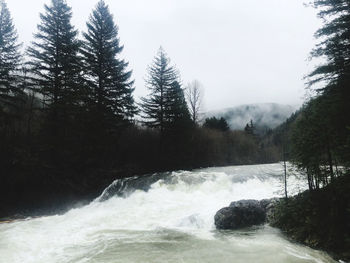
[309,0,350,168]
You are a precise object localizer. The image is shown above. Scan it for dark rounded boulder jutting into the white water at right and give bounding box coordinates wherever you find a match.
[214,198,280,229]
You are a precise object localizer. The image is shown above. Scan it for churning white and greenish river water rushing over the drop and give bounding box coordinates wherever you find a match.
[0,164,340,263]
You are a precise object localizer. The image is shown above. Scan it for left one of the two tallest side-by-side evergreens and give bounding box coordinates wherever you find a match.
[28,0,82,121]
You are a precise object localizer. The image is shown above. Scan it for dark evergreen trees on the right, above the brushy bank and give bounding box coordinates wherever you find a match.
[292,0,350,190]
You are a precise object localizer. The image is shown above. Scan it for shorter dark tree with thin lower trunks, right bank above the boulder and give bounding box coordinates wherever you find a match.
[292,96,336,190]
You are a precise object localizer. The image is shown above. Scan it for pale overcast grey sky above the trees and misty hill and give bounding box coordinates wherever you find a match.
[5,0,321,110]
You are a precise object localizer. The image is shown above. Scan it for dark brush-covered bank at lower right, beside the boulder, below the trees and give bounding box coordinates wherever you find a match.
[270,174,350,262]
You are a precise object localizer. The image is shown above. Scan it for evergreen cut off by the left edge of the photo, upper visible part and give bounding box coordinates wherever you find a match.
[0,0,22,110]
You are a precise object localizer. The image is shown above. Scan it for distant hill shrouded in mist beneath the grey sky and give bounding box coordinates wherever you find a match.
[205,103,298,131]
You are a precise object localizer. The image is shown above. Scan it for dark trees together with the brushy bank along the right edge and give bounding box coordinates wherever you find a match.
[266,0,350,261]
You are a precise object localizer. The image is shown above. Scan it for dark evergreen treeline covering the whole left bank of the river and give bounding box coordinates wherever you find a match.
[0,0,278,217]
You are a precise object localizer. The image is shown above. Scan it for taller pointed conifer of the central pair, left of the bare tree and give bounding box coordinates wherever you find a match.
[141,48,179,132]
